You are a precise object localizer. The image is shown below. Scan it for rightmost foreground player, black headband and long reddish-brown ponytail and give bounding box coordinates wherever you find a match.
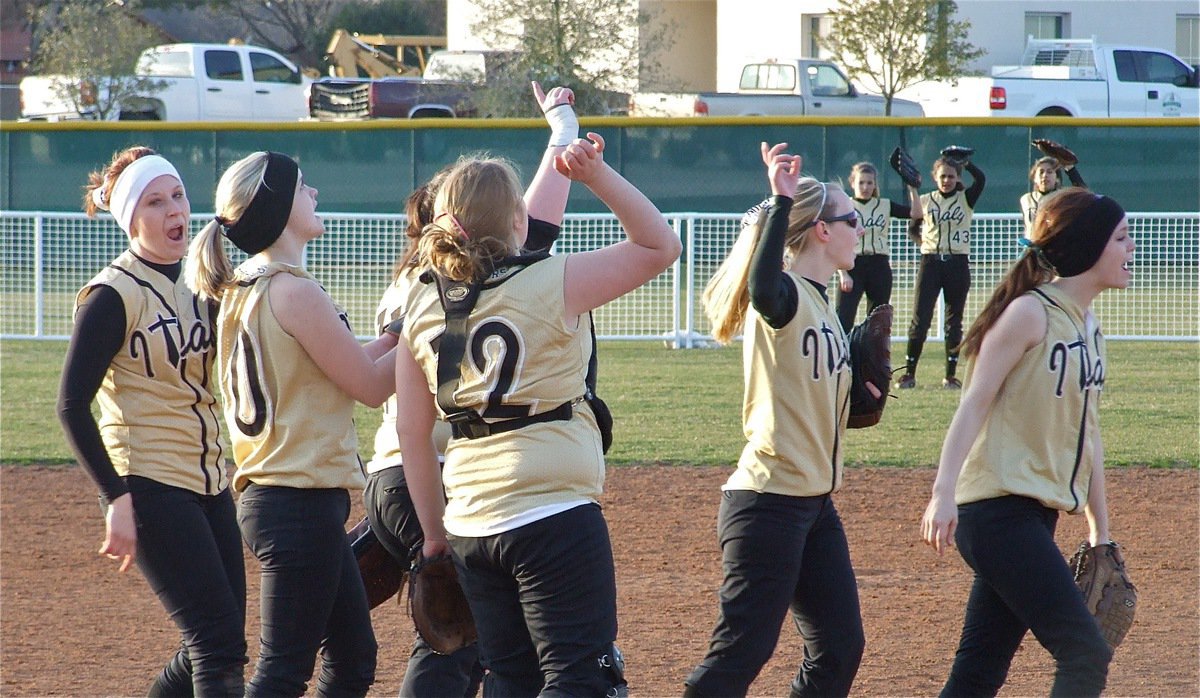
[920,188,1135,696]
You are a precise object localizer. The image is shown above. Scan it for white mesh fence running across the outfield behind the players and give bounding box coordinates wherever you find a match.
[0,211,1200,347]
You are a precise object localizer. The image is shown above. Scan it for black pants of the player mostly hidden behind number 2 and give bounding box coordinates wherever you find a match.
[362,465,484,698]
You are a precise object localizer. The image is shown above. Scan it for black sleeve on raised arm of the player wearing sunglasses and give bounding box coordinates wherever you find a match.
[746,197,799,330]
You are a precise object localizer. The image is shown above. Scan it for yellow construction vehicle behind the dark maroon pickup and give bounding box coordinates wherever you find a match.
[325,29,446,78]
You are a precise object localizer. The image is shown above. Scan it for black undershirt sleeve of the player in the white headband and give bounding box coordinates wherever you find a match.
[58,285,128,504]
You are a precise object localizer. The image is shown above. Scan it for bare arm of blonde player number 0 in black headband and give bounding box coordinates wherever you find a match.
[269,273,396,407]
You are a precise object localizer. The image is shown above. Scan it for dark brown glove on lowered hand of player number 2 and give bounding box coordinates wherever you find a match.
[408,553,479,655]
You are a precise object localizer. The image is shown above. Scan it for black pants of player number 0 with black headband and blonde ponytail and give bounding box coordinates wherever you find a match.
[238,483,376,698]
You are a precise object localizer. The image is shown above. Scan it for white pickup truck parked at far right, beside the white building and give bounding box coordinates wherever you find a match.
[988,38,1200,118]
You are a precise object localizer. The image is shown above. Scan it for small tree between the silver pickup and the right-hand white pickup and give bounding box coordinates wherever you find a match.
[818,0,986,115]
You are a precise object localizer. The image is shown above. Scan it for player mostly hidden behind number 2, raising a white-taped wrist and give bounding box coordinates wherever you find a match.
[362,83,578,698]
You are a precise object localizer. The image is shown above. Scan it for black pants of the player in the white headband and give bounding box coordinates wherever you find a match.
[125,475,247,696]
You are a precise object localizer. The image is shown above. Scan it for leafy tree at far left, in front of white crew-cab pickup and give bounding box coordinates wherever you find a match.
[34,2,163,119]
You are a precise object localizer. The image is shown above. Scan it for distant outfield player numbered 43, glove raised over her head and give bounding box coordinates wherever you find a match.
[896,157,985,390]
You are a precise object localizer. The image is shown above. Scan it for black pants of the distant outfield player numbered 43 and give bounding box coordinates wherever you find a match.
[907,254,971,377]
